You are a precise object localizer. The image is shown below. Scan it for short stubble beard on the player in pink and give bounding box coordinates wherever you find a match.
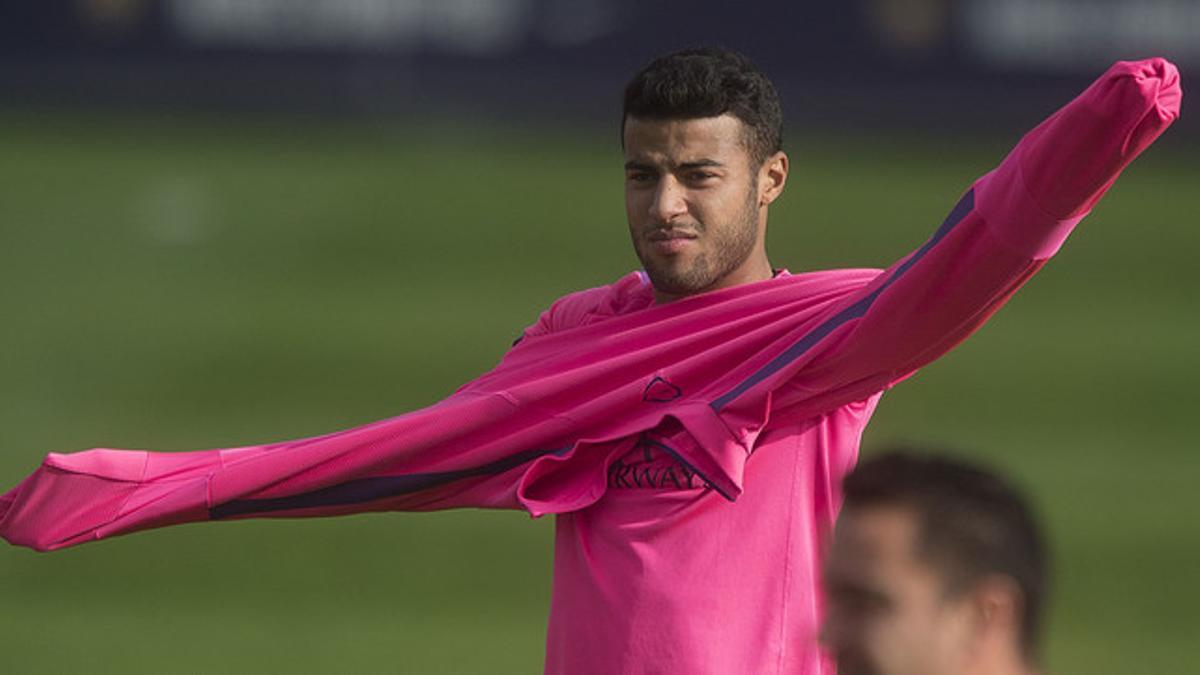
[635,185,758,295]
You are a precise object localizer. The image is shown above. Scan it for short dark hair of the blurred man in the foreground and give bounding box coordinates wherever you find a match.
[842,449,1049,664]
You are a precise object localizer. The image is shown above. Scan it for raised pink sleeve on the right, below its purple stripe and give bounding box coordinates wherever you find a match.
[730,59,1181,417]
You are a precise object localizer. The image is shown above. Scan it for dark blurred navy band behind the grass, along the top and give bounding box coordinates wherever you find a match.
[0,0,1200,133]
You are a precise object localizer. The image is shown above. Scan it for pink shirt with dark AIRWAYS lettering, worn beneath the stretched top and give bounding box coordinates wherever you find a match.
[526,273,880,674]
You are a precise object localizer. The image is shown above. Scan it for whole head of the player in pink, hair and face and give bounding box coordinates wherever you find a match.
[622,48,787,300]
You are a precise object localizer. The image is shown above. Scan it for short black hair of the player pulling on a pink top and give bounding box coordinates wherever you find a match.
[620,47,784,165]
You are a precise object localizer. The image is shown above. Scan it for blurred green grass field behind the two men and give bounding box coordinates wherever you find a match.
[0,114,1200,675]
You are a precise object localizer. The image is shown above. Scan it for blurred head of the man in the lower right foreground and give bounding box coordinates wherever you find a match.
[822,453,1048,675]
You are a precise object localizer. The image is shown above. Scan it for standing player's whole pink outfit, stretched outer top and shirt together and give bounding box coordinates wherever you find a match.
[0,59,1181,674]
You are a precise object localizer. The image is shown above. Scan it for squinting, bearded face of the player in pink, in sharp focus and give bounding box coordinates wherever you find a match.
[624,114,772,299]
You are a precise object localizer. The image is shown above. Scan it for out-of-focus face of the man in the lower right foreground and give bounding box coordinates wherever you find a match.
[821,506,973,675]
